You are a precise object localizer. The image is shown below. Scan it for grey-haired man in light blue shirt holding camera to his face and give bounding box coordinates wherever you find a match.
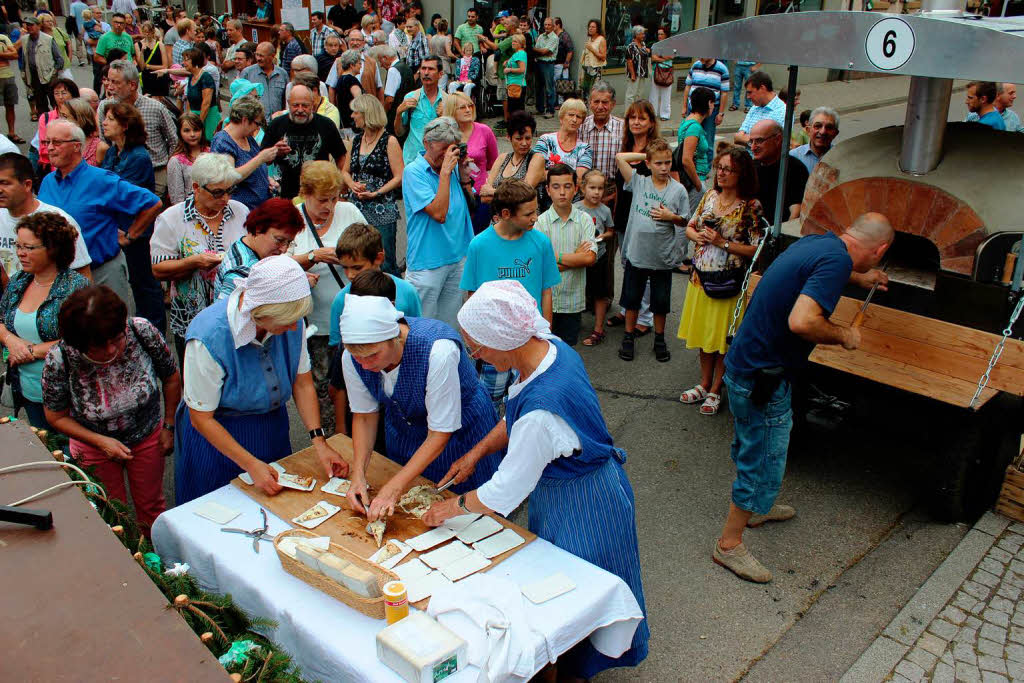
[401,116,473,326]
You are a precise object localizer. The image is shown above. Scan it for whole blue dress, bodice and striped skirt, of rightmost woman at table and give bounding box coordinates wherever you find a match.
[505,339,650,679]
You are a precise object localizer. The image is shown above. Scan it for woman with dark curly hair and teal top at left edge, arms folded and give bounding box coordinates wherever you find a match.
[0,212,89,429]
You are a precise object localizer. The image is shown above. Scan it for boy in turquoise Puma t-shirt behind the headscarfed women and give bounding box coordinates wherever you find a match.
[459,179,561,404]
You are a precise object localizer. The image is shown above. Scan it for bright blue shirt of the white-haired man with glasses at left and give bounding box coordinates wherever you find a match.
[39,161,160,268]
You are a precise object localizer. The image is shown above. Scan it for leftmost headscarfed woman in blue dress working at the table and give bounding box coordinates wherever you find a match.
[174,256,348,505]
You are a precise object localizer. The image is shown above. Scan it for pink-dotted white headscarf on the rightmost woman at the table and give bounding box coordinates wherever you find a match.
[459,280,551,351]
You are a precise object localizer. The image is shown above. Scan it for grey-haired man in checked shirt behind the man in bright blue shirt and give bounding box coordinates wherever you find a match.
[96,59,178,197]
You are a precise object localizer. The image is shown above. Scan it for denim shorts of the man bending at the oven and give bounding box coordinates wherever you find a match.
[725,372,793,515]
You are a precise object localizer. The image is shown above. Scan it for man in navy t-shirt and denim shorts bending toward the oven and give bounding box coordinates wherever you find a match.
[712,213,893,584]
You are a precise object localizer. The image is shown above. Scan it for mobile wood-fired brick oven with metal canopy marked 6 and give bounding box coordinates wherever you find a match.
[653,0,1024,519]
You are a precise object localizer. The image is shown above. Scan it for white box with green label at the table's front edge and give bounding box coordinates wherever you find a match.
[377,611,468,683]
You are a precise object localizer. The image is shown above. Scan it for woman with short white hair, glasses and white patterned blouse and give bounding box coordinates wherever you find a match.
[150,154,249,359]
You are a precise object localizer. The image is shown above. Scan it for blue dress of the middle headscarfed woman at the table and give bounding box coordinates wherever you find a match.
[352,317,503,494]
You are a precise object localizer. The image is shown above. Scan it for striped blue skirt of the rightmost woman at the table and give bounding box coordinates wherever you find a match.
[529,458,650,678]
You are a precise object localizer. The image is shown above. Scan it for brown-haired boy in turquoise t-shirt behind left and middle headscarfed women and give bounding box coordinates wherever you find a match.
[328,223,422,438]
